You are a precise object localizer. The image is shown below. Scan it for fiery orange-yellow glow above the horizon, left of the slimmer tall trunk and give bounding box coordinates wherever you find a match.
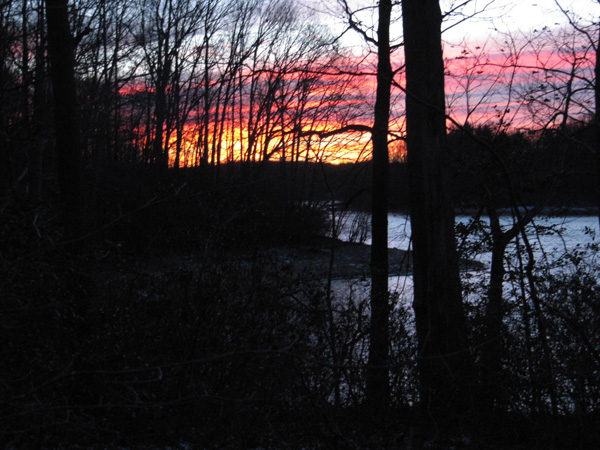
[134,62,374,167]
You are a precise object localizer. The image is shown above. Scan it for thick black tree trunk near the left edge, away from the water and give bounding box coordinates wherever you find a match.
[46,0,82,240]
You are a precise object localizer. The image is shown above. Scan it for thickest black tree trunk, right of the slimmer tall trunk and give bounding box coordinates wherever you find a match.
[402,0,473,425]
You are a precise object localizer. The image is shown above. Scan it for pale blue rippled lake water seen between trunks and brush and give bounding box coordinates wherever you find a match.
[332,213,600,412]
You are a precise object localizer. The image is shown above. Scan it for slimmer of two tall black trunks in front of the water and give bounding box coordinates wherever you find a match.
[366,0,393,409]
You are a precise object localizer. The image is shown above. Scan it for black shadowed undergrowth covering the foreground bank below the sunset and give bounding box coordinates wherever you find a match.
[0,139,600,449]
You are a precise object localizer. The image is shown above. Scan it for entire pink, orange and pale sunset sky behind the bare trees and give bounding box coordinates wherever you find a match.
[4,0,600,165]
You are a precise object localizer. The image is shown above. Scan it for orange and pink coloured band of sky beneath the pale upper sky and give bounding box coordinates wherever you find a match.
[120,28,593,167]
